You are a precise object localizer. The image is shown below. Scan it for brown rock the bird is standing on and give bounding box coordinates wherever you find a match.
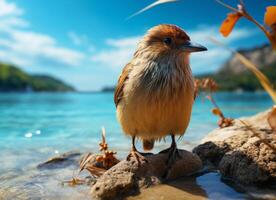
[91,150,202,199]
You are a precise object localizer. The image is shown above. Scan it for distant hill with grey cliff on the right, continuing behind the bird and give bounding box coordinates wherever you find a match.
[102,44,276,92]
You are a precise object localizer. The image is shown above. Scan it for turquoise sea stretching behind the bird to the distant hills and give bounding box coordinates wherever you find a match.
[0,93,272,172]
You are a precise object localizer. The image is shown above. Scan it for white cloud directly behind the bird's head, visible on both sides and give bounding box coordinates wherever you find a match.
[91,26,255,73]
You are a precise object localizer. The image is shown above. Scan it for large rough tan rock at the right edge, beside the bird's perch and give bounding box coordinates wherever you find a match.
[193,110,276,185]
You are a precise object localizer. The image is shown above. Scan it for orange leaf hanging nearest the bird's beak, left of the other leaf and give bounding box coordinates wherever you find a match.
[219,13,242,37]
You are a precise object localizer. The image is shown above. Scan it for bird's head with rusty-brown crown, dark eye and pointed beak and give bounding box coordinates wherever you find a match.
[137,24,207,56]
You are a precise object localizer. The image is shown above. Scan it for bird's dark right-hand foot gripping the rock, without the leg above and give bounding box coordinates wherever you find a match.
[160,146,181,179]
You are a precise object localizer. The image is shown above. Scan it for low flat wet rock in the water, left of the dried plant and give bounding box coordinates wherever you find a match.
[37,151,81,170]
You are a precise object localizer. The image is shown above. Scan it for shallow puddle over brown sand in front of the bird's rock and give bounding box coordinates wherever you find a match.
[129,173,247,200]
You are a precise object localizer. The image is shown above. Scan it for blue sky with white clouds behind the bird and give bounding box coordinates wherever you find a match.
[0,0,276,91]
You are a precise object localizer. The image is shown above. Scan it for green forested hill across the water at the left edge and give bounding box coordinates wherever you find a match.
[0,63,75,92]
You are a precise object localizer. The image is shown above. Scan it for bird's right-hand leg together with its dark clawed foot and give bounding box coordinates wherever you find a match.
[160,134,181,178]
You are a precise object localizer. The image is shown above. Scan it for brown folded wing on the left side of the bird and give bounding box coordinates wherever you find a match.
[114,63,132,107]
